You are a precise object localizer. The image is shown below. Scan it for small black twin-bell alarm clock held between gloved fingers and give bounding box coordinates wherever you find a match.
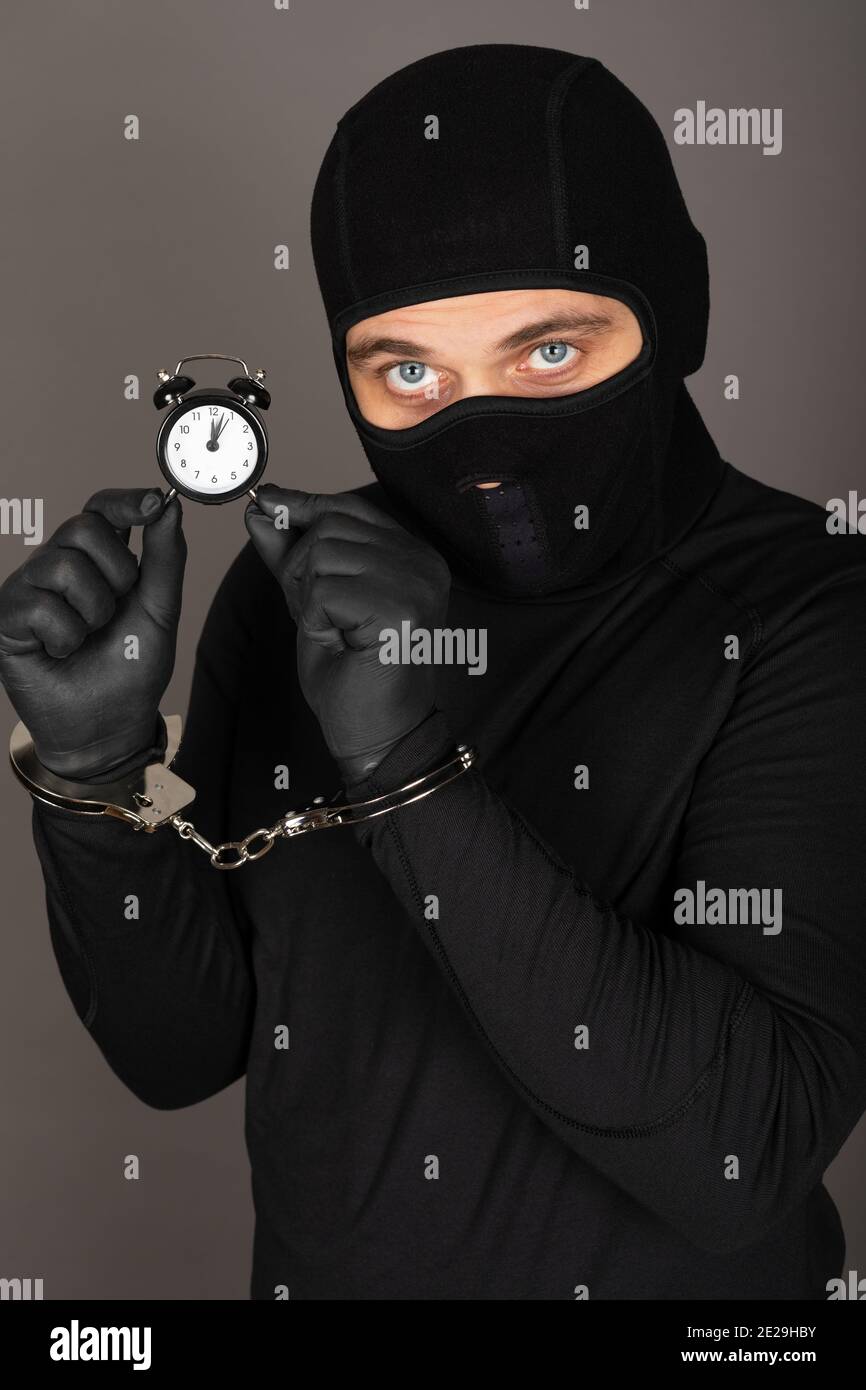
[153,352,271,503]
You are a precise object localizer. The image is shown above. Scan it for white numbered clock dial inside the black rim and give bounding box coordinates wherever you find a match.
[163,404,259,496]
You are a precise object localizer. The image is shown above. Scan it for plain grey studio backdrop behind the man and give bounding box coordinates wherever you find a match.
[0,0,866,1298]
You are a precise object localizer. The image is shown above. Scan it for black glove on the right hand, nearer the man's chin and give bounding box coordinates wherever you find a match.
[245,484,450,787]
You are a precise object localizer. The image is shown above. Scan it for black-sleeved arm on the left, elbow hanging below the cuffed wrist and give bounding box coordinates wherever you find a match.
[27,542,254,1108]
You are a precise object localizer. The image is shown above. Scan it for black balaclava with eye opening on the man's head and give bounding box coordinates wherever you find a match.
[311,44,721,596]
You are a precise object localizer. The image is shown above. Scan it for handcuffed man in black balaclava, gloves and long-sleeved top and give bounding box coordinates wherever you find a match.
[10,44,866,1300]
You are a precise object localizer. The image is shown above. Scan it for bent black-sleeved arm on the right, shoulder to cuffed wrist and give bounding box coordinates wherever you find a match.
[343,581,866,1251]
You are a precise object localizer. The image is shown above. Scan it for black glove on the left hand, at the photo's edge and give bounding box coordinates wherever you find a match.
[0,488,186,781]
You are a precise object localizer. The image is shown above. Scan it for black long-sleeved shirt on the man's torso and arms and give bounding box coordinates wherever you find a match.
[27,467,866,1300]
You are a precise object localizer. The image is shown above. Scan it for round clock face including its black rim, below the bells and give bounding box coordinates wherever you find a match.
[157,399,265,502]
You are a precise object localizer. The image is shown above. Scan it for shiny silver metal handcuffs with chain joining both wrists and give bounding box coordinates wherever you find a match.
[10,714,477,869]
